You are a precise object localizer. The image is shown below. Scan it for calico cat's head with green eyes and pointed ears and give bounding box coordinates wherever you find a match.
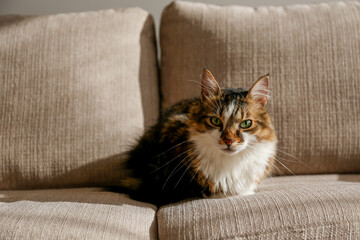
[193,69,276,155]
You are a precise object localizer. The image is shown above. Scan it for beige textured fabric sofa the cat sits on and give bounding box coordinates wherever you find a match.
[0,2,360,239]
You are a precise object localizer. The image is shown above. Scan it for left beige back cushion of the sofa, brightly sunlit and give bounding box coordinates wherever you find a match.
[0,8,159,189]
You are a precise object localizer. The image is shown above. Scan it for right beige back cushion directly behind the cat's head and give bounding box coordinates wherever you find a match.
[160,2,360,174]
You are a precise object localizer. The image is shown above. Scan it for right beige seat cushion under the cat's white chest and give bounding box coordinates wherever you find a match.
[158,175,360,239]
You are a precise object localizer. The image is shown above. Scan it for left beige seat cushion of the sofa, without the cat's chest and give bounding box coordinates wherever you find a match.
[0,188,157,239]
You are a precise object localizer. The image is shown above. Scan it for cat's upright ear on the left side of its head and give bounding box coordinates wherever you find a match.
[201,68,221,101]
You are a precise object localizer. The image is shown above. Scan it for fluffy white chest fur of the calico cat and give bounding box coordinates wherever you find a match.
[191,133,276,195]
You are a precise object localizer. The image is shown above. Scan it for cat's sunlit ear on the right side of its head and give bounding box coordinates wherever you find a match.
[247,74,270,107]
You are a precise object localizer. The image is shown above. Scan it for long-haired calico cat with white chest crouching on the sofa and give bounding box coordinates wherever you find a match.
[119,69,277,206]
